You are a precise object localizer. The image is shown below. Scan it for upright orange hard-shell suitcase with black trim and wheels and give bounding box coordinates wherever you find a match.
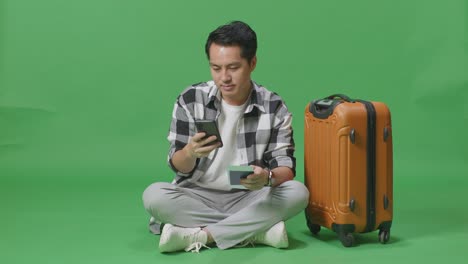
[304,94,393,247]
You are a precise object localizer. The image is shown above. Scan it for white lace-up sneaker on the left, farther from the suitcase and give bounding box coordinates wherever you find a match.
[159,224,209,253]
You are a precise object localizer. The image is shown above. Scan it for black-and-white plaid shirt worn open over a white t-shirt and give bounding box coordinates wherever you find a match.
[167,81,296,185]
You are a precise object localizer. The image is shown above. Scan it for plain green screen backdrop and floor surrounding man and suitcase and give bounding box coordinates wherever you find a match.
[0,0,468,263]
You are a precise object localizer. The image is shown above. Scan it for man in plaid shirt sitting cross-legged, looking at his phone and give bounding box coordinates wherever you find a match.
[143,21,309,252]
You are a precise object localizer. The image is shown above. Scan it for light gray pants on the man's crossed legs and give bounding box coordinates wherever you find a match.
[143,181,309,249]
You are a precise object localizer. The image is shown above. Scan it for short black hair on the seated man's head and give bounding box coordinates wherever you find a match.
[205,21,257,63]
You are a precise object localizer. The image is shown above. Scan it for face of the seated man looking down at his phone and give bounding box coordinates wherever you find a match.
[209,43,257,105]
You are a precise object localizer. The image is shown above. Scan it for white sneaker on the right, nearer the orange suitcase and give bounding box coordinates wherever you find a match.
[243,221,289,248]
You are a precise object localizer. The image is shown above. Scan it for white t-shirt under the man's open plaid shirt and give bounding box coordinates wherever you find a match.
[196,100,249,190]
